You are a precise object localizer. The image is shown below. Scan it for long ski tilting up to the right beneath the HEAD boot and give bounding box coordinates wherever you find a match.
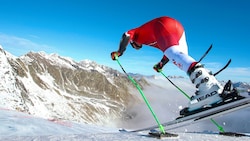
[120,97,250,132]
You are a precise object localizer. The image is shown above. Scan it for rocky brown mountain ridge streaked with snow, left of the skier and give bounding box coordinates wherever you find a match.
[0,47,146,125]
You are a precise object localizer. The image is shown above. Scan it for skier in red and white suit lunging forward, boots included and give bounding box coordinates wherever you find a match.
[111,16,223,111]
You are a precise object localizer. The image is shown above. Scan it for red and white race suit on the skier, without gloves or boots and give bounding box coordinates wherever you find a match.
[120,16,195,72]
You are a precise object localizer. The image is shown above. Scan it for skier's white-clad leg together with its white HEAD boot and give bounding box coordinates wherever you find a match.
[164,35,223,111]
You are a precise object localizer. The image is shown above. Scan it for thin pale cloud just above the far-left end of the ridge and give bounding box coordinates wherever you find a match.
[0,33,54,56]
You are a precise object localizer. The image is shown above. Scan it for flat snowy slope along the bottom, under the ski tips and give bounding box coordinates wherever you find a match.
[0,108,250,141]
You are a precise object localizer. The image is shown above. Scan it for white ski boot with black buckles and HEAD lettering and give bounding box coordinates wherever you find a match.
[188,63,223,112]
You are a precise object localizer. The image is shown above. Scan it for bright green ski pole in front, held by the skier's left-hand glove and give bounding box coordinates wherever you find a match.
[115,56,165,134]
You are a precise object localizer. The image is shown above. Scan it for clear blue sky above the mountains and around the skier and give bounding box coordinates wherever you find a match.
[0,0,250,82]
